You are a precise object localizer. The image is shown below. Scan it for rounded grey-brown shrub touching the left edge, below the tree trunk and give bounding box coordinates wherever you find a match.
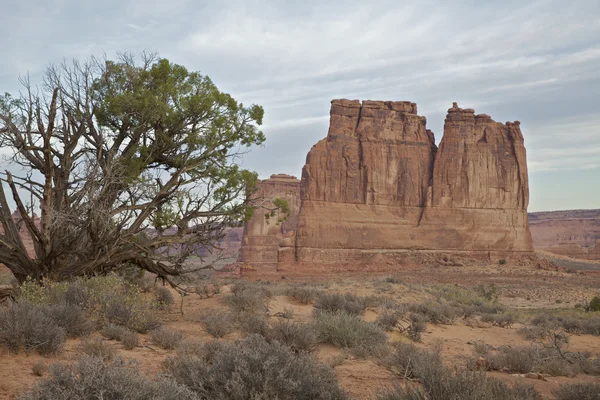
[0,300,67,354]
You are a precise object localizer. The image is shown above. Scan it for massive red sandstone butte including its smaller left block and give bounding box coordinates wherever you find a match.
[239,99,535,269]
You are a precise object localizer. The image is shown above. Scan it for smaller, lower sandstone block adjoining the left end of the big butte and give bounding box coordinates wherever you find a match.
[239,174,300,268]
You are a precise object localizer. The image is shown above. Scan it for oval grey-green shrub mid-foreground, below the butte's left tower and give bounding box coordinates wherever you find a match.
[314,311,387,353]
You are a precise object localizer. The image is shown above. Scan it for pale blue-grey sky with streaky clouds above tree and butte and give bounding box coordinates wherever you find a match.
[0,0,600,211]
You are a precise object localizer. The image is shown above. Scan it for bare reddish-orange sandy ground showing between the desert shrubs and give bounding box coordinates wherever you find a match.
[0,266,600,399]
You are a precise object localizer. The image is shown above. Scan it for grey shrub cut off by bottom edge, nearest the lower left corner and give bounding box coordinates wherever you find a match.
[20,356,197,400]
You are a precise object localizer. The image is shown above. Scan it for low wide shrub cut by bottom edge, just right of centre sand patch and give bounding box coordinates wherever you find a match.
[377,369,542,400]
